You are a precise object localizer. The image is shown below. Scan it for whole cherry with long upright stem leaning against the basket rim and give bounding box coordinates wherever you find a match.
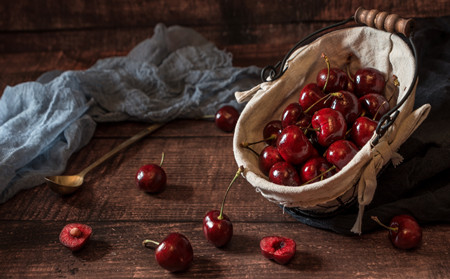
[203,166,244,247]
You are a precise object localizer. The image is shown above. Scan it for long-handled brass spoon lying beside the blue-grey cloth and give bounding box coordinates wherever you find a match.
[45,123,164,195]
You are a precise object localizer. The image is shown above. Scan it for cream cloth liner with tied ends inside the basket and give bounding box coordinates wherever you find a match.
[233,27,431,233]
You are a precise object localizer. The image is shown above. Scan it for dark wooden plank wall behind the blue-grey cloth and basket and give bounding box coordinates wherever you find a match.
[0,0,450,94]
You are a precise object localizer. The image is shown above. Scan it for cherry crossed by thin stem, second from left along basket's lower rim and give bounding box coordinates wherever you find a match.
[299,157,336,183]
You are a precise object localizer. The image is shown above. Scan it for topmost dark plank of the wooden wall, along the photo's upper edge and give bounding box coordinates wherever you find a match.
[0,0,450,31]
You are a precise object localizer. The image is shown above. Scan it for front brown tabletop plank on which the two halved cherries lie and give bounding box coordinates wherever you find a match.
[0,222,450,278]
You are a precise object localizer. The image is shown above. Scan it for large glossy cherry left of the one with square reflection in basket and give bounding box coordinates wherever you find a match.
[277,125,314,165]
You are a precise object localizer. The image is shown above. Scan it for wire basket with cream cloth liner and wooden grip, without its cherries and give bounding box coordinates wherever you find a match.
[233,8,430,233]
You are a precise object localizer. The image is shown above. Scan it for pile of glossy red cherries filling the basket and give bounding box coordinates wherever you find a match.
[246,54,390,186]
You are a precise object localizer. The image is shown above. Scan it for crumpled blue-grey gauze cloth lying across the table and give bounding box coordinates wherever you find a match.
[0,24,260,203]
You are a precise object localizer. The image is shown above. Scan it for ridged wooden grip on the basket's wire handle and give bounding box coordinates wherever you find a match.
[354,7,414,37]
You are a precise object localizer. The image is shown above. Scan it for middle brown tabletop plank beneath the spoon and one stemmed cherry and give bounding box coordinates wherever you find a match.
[0,131,293,222]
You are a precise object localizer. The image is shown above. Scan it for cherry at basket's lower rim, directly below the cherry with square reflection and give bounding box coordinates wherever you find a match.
[325,140,358,170]
